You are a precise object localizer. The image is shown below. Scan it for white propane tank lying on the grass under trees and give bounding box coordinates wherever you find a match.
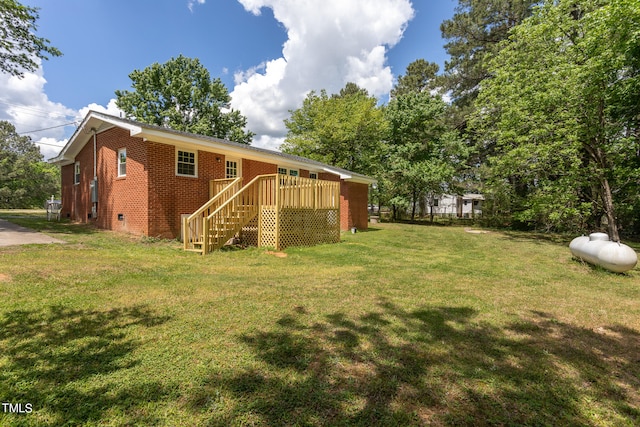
[569,233,638,273]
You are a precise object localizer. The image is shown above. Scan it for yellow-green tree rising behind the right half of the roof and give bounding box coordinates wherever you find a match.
[282,83,386,175]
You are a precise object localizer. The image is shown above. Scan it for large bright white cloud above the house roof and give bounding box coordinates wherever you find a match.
[231,0,414,148]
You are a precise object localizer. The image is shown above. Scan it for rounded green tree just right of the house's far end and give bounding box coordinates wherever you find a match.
[384,92,468,220]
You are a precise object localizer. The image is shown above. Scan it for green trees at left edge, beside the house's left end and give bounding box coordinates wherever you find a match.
[0,121,60,209]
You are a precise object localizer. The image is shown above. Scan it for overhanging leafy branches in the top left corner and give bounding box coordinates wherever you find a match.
[0,0,62,77]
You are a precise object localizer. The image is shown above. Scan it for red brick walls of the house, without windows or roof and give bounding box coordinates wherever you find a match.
[62,128,368,238]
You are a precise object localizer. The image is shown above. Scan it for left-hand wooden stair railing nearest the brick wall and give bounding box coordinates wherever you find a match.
[182,178,242,250]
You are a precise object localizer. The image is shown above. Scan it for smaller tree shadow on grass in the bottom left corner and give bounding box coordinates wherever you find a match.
[0,306,168,425]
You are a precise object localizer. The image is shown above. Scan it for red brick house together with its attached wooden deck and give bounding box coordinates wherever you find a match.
[51,111,375,253]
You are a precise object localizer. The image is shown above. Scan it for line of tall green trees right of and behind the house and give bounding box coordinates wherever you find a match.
[284,0,640,240]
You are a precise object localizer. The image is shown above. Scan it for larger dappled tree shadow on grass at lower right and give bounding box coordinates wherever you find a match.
[191,301,640,426]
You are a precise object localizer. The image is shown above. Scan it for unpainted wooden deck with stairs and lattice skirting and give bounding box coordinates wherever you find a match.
[183,174,340,254]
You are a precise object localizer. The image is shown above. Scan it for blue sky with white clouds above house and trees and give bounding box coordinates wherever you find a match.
[0,0,457,157]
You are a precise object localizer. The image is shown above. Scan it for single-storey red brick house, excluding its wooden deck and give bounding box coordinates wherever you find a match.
[51,111,375,251]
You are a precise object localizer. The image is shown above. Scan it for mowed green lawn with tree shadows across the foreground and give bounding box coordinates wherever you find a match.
[0,211,640,426]
